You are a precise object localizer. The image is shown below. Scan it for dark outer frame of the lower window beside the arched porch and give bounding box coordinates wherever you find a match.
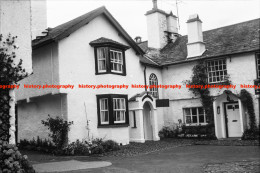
[96,94,129,128]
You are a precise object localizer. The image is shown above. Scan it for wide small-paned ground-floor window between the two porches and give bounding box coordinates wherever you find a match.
[183,107,206,125]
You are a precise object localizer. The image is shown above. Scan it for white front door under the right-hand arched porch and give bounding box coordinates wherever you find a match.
[226,103,242,137]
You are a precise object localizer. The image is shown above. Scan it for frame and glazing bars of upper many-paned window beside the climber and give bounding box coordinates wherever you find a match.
[206,58,228,84]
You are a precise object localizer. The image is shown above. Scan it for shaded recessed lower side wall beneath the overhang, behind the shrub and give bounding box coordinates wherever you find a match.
[17,95,67,141]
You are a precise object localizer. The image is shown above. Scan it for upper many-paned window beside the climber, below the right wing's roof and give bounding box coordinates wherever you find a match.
[207,59,227,83]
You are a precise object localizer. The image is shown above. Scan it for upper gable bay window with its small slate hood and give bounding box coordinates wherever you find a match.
[90,37,129,76]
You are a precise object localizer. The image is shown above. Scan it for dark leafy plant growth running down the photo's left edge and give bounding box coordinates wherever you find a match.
[0,34,35,173]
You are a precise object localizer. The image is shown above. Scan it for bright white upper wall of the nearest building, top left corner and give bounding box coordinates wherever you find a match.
[0,0,32,72]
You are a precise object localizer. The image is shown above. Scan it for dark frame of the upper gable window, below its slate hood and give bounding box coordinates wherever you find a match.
[94,45,126,76]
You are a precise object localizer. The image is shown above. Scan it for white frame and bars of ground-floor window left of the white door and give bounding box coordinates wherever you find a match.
[182,106,208,126]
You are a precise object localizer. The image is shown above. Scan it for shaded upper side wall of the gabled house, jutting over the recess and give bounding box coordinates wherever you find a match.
[16,43,60,100]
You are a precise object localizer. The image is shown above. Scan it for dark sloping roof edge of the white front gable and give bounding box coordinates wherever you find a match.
[32,6,144,55]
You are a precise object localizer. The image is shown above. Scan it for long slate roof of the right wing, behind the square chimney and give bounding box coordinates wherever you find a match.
[139,19,260,66]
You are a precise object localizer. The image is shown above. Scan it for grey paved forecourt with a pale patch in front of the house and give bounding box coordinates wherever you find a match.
[33,145,260,173]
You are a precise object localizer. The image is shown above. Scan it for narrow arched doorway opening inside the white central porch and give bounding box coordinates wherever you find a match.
[143,103,153,140]
